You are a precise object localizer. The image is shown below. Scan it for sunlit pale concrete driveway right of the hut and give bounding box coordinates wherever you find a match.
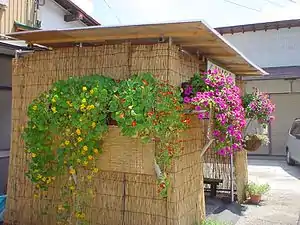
[237,159,300,225]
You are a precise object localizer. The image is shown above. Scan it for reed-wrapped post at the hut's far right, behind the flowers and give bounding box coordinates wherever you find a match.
[233,76,248,203]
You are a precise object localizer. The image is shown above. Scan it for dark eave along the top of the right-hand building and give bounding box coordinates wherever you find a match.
[215,19,300,35]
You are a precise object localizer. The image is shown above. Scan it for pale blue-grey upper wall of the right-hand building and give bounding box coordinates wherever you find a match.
[224,27,300,67]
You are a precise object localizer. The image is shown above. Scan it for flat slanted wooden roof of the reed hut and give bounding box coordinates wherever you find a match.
[8,21,267,76]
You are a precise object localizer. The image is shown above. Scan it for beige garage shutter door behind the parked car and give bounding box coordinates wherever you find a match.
[271,94,300,155]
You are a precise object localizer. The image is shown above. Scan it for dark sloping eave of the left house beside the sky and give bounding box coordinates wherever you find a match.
[54,0,101,26]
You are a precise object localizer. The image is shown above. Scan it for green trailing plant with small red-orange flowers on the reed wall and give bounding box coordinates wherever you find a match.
[110,73,189,197]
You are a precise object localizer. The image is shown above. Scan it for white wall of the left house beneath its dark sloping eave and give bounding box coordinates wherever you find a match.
[39,0,86,29]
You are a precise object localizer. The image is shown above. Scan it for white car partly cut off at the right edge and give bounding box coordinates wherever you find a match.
[286,118,300,166]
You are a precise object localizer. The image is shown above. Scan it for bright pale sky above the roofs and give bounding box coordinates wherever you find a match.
[73,0,300,27]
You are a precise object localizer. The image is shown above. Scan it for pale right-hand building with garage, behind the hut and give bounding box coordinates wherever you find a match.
[216,19,300,155]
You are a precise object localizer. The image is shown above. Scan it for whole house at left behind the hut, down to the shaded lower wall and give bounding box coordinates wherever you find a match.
[0,0,100,195]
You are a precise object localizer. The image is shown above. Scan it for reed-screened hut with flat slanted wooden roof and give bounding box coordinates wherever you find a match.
[6,21,265,225]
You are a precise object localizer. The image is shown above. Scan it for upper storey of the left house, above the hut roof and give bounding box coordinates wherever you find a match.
[0,0,100,34]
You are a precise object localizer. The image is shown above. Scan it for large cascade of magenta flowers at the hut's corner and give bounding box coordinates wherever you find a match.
[184,71,246,155]
